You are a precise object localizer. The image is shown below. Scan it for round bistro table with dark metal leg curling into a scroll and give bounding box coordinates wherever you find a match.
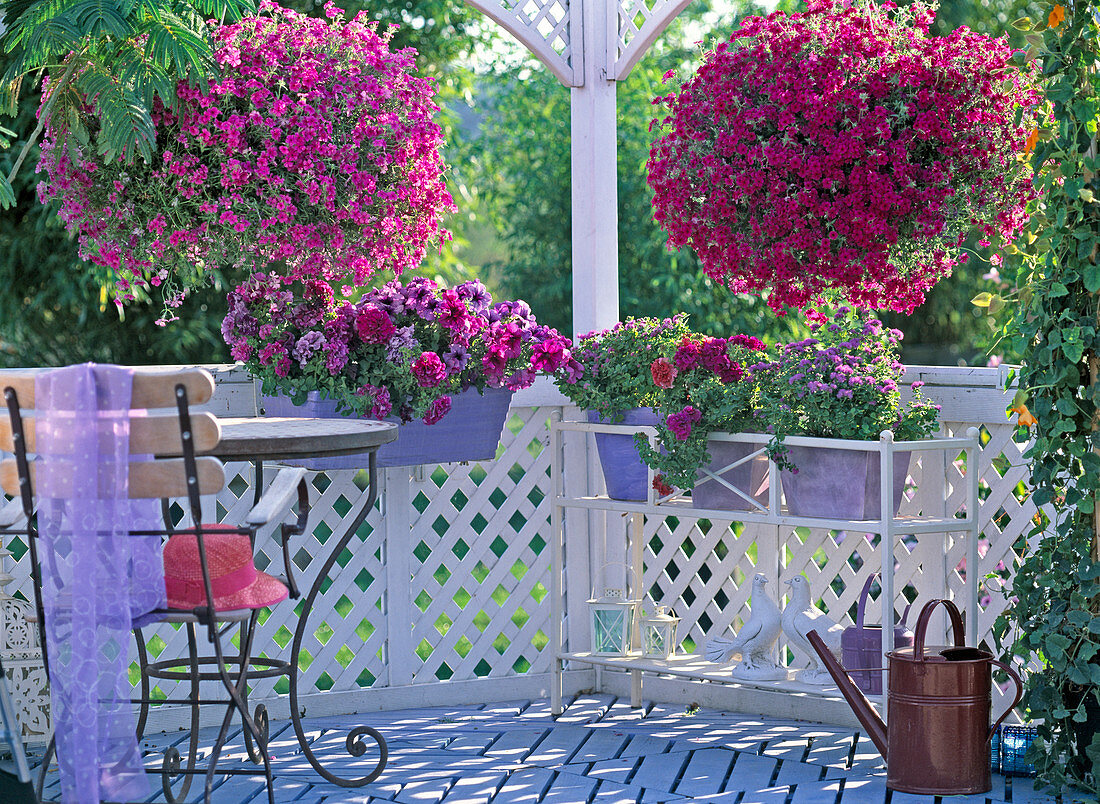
[210,418,397,788]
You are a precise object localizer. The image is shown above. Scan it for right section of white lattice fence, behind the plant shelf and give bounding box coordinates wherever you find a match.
[574,368,1036,712]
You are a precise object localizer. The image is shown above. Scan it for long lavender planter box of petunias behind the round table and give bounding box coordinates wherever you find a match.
[261,388,512,470]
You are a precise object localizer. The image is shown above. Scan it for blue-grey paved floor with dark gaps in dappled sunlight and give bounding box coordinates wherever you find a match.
[27,695,1073,804]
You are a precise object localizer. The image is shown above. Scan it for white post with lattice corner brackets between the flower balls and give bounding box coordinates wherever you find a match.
[466,0,691,334]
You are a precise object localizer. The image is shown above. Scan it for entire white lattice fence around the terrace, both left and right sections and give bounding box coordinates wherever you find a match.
[4,368,1035,733]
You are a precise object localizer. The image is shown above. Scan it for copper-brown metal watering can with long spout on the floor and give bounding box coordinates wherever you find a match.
[807,601,1023,795]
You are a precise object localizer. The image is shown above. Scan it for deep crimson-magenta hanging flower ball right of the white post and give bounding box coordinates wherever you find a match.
[649,0,1040,312]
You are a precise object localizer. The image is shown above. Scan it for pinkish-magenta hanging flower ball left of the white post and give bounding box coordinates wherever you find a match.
[40,1,453,321]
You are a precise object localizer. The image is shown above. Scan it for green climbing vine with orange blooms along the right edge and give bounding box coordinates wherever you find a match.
[998,0,1100,794]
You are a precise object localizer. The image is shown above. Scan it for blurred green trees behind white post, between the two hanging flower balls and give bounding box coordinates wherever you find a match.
[473,0,798,339]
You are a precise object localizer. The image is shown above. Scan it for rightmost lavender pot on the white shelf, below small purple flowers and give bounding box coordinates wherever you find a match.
[780,447,913,520]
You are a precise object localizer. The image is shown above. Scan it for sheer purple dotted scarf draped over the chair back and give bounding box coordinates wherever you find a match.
[35,363,166,804]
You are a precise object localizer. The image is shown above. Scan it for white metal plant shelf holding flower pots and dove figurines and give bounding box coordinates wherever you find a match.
[550,418,980,714]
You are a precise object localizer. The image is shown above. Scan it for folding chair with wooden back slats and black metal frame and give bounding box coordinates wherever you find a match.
[0,368,309,804]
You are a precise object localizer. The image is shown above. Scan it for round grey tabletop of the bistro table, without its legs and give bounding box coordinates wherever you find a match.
[208,417,397,461]
